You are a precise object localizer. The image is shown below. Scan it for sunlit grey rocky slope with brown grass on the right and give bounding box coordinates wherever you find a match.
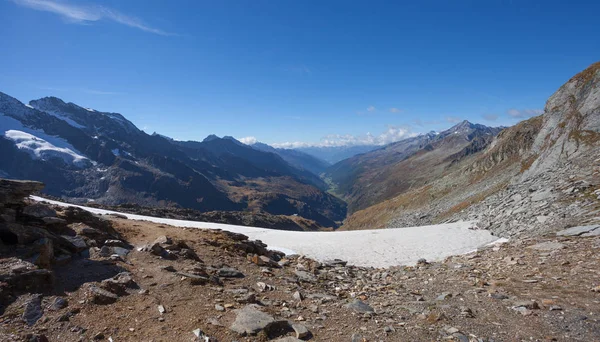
[344,63,600,237]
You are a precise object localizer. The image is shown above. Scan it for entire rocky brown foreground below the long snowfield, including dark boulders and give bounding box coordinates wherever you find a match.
[0,180,600,342]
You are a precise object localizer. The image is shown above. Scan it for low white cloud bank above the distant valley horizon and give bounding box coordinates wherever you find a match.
[272,125,418,148]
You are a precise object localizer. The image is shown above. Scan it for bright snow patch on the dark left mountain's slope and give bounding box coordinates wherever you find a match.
[4,129,89,167]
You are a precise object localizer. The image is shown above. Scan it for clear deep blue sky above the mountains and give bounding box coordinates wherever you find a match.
[0,0,600,146]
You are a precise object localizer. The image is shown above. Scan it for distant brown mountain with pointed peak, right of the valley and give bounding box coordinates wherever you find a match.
[325,121,501,212]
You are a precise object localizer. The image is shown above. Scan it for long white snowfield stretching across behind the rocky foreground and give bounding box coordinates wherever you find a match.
[32,196,498,267]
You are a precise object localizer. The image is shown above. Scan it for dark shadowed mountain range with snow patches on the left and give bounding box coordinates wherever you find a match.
[0,93,346,227]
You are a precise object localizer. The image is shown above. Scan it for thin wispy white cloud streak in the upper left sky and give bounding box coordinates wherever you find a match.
[13,0,175,36]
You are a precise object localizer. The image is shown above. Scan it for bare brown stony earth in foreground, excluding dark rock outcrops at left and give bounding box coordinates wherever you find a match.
[0,212,600,341]
